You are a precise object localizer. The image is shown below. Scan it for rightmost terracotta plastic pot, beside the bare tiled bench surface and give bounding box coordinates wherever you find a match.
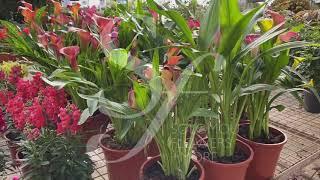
[238,124,287,180]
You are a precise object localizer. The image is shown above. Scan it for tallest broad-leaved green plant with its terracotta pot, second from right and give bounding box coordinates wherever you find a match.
[155,0,312,179]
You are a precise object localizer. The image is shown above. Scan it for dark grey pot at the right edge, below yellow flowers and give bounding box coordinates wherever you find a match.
[303,91,320,113]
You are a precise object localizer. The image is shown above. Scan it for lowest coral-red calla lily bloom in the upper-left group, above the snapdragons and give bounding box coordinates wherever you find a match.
[59,46,80,71]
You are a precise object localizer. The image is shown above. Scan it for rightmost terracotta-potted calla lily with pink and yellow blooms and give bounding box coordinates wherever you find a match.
[238,12,303,180]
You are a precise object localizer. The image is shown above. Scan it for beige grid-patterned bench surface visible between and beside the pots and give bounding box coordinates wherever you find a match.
[0,92,320,180]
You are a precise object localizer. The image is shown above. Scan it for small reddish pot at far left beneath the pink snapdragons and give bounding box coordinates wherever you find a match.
[3,130,20,165]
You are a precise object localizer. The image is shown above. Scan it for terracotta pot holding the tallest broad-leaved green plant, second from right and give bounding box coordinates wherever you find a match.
[201,140,252,180]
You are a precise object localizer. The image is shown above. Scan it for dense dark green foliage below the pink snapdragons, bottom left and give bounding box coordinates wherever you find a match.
[22,129,93,180]
